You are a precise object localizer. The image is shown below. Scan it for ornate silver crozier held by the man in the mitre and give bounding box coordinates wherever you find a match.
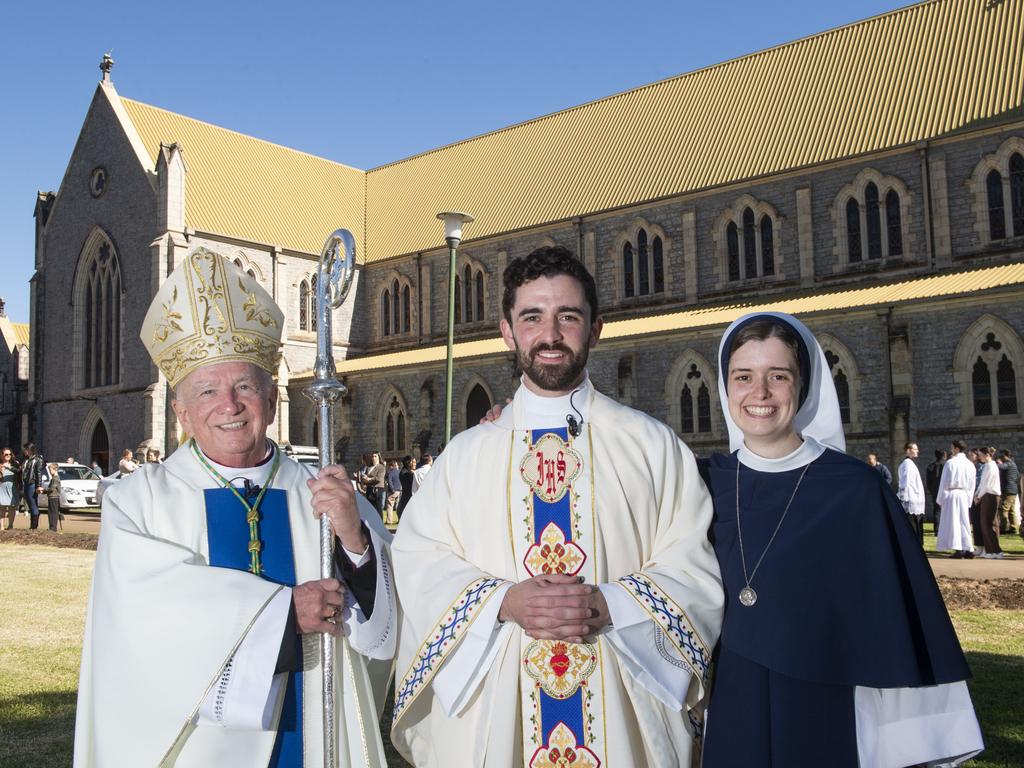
[304,229,355,768]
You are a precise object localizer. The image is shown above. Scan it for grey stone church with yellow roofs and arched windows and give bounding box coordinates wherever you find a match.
[27,0,1024,468]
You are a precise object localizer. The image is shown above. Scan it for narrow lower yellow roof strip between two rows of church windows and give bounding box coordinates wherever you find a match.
[311,263,1024,379]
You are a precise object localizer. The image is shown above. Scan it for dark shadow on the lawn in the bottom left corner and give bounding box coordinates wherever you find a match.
[0,691,78,768]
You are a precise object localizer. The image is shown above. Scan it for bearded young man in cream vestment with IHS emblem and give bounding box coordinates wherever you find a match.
[392,247,723,768]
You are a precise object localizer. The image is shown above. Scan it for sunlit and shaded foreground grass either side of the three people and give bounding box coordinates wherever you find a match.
[0,537,1024,768]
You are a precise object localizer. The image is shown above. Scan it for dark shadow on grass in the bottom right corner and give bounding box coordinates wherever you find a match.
[967,651,1024,768]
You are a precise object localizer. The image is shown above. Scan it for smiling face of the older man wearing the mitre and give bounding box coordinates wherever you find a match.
[171,362,278,467]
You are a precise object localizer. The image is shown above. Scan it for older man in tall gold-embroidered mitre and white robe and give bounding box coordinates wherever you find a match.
[74,249,397,768]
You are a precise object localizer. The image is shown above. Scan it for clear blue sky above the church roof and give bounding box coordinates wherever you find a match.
[0,0,907,322]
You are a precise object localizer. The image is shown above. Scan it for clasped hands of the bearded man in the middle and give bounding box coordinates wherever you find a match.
[498,573,611,643]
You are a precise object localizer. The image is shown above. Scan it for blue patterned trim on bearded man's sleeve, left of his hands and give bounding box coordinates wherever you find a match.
[392,579,502,722]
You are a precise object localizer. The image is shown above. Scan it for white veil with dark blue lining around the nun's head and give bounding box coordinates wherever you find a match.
[718,312,846,453]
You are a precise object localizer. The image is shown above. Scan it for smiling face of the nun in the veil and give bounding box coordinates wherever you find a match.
[727,336,800,458]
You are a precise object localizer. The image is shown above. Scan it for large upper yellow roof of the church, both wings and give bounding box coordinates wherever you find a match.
[112,0,1024,261]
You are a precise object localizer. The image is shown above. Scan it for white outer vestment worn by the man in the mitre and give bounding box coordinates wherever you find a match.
[75,445,397,768]
